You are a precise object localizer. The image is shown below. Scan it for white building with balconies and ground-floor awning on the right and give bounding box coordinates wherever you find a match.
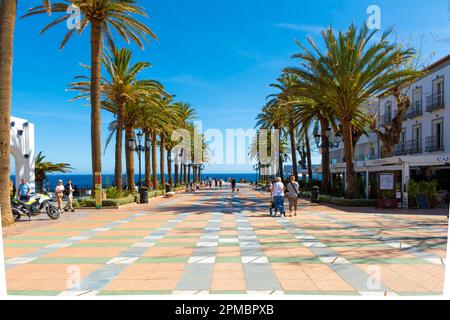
[331,55,450,205]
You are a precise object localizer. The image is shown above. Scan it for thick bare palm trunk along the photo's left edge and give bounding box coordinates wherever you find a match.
[0,0,17,227]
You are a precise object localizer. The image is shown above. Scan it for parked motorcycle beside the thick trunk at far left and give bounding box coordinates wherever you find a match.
[11,192,60,221]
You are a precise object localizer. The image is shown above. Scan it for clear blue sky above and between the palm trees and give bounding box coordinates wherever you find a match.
[13,0,450,173]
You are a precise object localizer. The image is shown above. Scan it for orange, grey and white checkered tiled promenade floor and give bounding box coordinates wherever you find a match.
[4,187,448,296]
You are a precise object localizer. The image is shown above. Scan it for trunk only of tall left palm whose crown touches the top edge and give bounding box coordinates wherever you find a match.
[91,20,103,194]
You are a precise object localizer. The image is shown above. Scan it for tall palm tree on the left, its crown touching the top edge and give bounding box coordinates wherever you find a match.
[23,0,156,190]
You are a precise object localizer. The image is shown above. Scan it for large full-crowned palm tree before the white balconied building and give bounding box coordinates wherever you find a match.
[288,25,414,198]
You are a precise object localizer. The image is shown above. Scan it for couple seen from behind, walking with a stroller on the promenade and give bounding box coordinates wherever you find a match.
[270,176,300,217]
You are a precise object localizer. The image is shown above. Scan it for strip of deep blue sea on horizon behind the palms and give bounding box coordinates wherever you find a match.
[11,173,256,190]
